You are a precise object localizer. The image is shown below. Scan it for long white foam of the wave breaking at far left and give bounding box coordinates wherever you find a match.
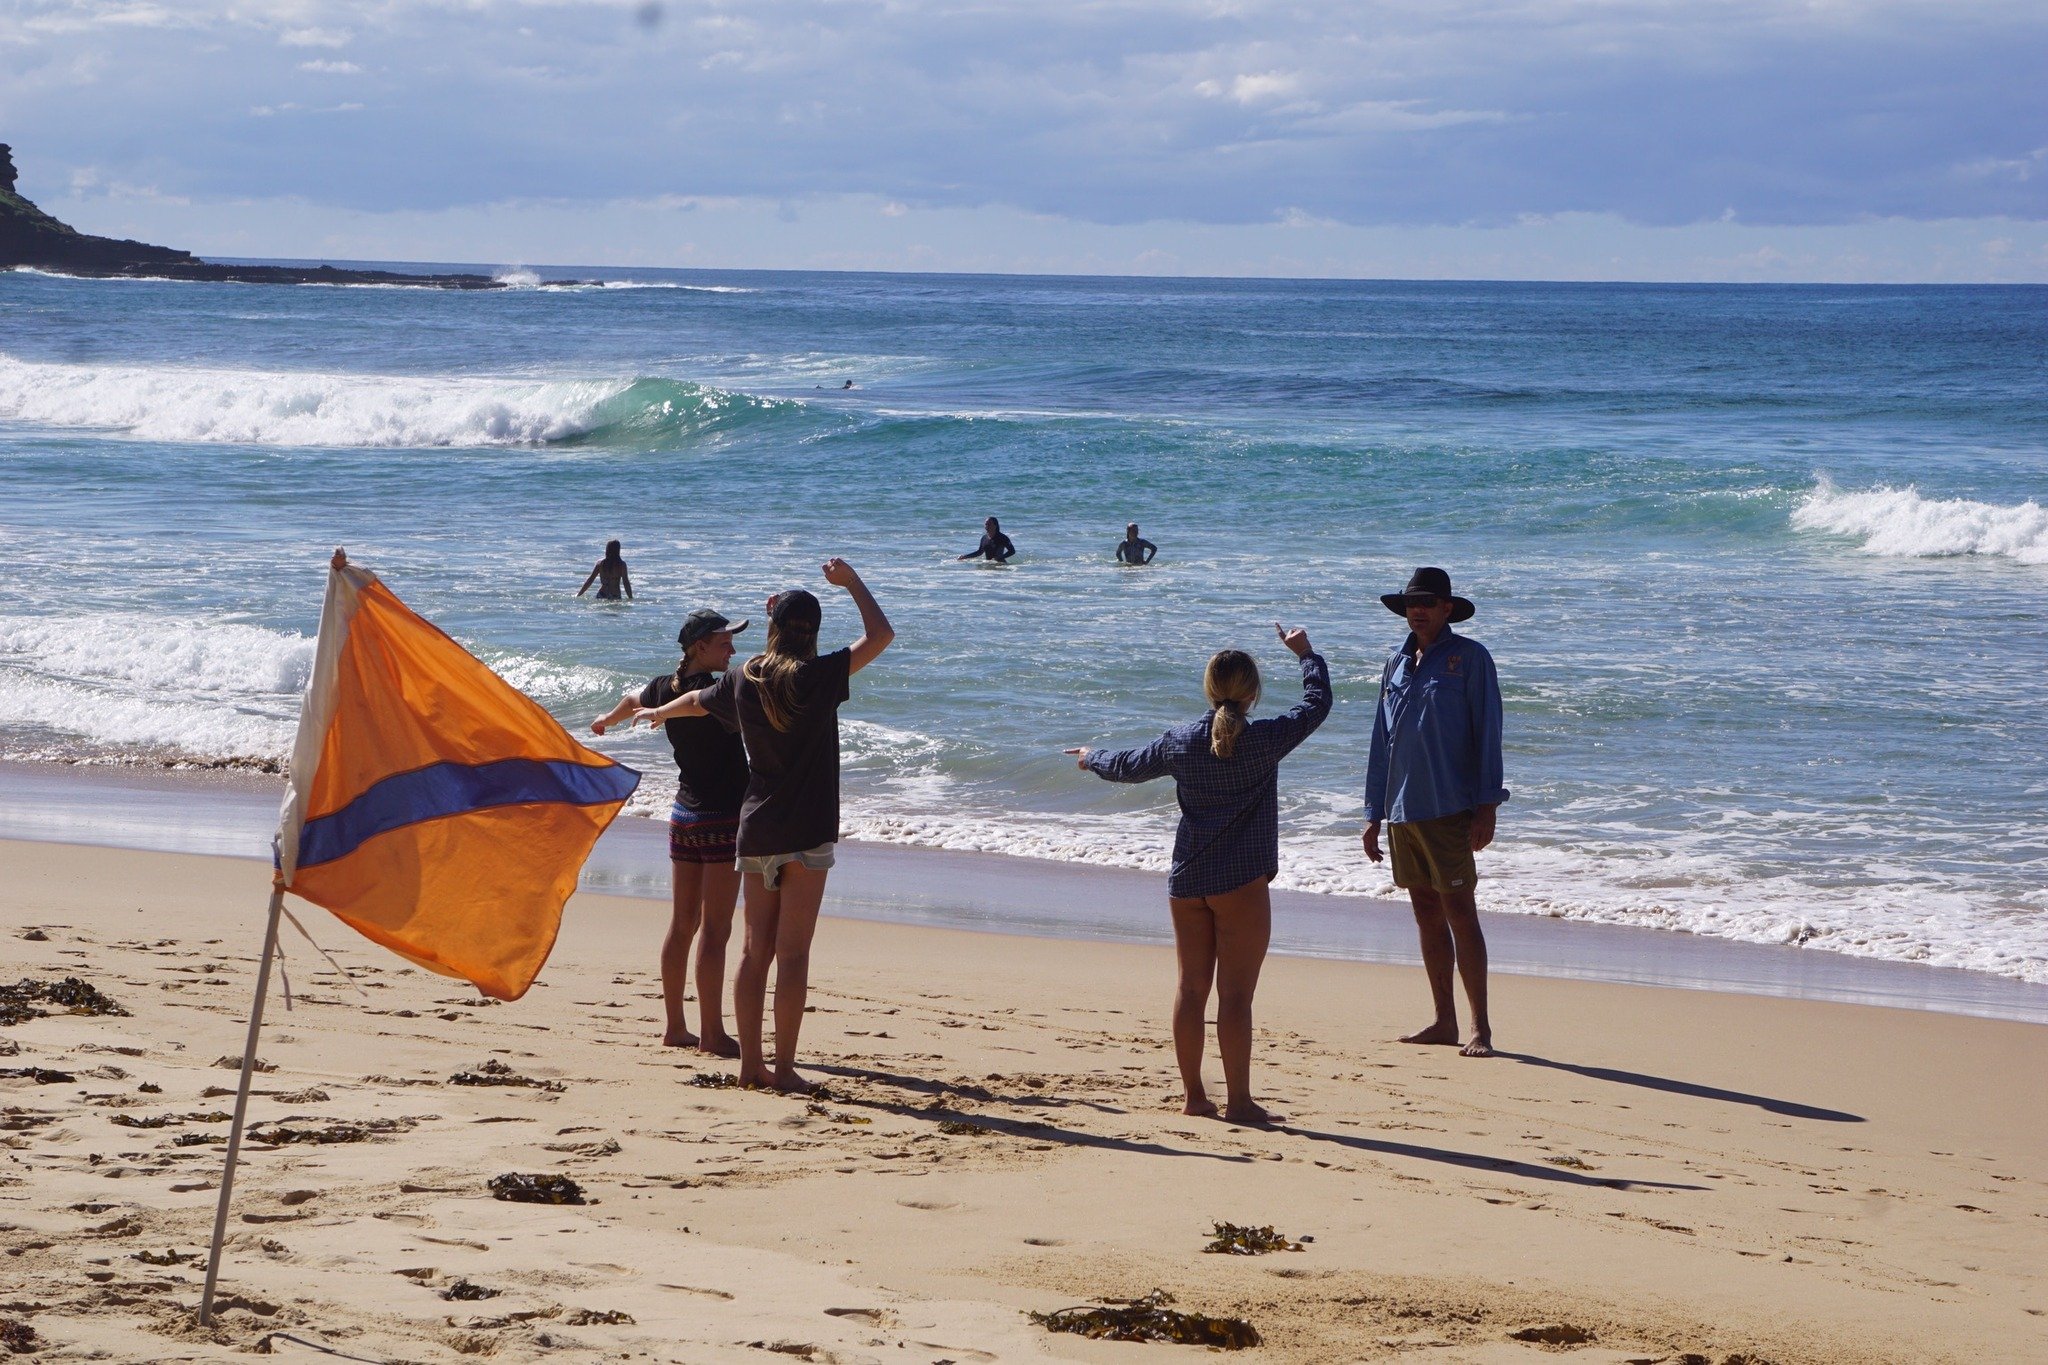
[0,356,647,446]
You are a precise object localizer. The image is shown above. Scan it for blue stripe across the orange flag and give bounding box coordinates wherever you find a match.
[299,759,639,868]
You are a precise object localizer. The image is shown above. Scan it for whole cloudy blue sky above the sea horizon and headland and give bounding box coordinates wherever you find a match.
[0,0,2048,282]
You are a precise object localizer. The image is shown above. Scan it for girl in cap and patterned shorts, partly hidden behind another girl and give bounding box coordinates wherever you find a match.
[590,608,748,1056]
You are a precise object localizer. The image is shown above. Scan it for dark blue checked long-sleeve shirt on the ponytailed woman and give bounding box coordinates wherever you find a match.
[1085,653,1331,896]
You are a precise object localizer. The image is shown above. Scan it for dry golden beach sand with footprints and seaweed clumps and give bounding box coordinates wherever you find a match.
[0,843,2048,1365]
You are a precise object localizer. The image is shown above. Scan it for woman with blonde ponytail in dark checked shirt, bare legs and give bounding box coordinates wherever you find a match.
[1067,624,1331,1124]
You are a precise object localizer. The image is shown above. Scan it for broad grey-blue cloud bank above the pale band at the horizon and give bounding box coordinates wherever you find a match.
[0,0,2048,240]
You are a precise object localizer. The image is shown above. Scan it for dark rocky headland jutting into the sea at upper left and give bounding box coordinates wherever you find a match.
[0,143,548,289]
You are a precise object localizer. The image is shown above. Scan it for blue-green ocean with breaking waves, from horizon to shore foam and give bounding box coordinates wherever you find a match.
[0,268,2048,982]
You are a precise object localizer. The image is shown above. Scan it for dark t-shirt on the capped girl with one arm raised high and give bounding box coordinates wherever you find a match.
[702,649,854,857]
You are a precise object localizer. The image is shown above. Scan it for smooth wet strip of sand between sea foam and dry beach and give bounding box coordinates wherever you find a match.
[0,759,2048,1023]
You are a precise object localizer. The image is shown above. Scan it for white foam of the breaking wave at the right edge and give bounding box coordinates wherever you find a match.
[1792,479,2048,565]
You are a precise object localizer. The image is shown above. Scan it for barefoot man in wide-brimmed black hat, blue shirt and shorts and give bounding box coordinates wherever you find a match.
[1364,569,1507,1056]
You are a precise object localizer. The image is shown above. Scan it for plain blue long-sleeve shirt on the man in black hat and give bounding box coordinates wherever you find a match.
[1366,626,1507,825]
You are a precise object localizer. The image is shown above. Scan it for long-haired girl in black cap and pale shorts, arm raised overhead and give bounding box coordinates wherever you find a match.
[637,559,895,1091]
